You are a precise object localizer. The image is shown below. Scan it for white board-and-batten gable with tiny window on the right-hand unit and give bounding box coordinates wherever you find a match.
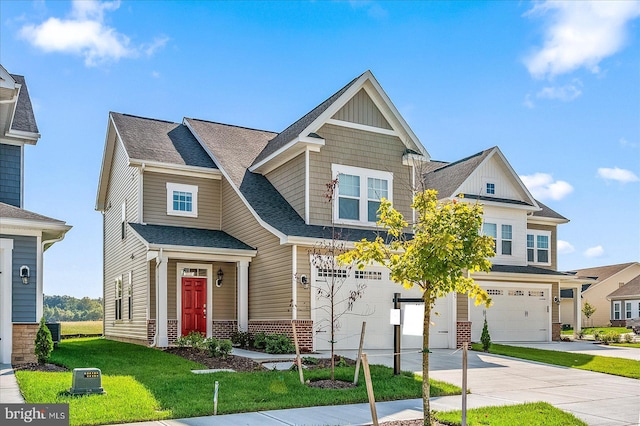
[460,155,529,202]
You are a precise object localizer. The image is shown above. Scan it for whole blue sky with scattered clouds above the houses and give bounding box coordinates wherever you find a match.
[0,0,640,297]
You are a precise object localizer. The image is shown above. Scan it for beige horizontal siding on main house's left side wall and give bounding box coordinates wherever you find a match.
[103,140,148,342]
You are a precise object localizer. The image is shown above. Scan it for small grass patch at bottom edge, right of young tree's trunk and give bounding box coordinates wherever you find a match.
[435,402,586,426]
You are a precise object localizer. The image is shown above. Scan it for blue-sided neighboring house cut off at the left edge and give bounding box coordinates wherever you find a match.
[0,65,71,364]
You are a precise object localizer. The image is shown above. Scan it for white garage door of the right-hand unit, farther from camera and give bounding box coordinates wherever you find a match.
[471,283,551,342]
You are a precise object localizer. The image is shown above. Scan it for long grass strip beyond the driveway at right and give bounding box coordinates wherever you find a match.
[472,343,640,379]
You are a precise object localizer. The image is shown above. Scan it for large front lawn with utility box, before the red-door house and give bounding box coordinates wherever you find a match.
[16,338,461,425]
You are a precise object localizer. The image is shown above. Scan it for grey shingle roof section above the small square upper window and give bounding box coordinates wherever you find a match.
[111,112,218,169]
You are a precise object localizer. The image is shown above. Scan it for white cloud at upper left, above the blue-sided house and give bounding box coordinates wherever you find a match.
[20,0,168,66]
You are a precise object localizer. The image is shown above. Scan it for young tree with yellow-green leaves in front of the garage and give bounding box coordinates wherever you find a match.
[339,190,494,425]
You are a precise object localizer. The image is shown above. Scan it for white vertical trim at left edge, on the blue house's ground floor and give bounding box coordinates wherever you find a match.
[0,238,13,364]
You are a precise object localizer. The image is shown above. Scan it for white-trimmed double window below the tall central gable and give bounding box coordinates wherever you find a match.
[331,164,393,226]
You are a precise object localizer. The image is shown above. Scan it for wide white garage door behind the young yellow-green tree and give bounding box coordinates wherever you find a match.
[311,267,455,350]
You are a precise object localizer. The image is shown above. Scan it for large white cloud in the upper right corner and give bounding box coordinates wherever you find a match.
[524,0,640,78]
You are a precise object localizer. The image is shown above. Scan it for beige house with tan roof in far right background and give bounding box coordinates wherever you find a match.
[560,262,640,327]
